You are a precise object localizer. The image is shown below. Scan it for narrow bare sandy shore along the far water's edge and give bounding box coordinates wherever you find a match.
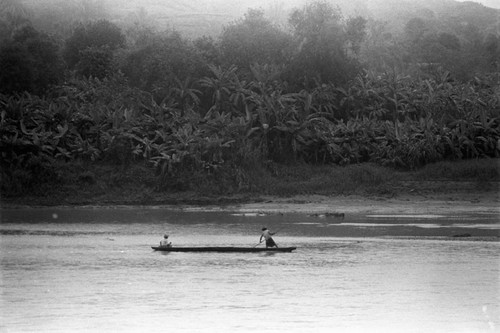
[1,182,500,215]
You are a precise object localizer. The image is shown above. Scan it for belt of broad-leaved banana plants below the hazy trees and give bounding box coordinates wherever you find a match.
[1,67,500,191]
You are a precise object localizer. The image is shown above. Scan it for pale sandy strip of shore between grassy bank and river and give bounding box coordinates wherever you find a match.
[1,184,500,215]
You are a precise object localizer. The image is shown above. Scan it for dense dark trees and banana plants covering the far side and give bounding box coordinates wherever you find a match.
[0,0,500,195]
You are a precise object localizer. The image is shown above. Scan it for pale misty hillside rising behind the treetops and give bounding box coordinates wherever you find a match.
[20,0,500,37]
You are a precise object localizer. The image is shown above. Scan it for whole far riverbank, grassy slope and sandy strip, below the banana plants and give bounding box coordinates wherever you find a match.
[1,160,500,217]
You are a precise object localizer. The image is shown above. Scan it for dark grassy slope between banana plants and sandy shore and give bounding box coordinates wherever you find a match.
[2,159,500,206]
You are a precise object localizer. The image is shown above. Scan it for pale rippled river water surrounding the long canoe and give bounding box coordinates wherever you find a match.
[0,207,500,332]
